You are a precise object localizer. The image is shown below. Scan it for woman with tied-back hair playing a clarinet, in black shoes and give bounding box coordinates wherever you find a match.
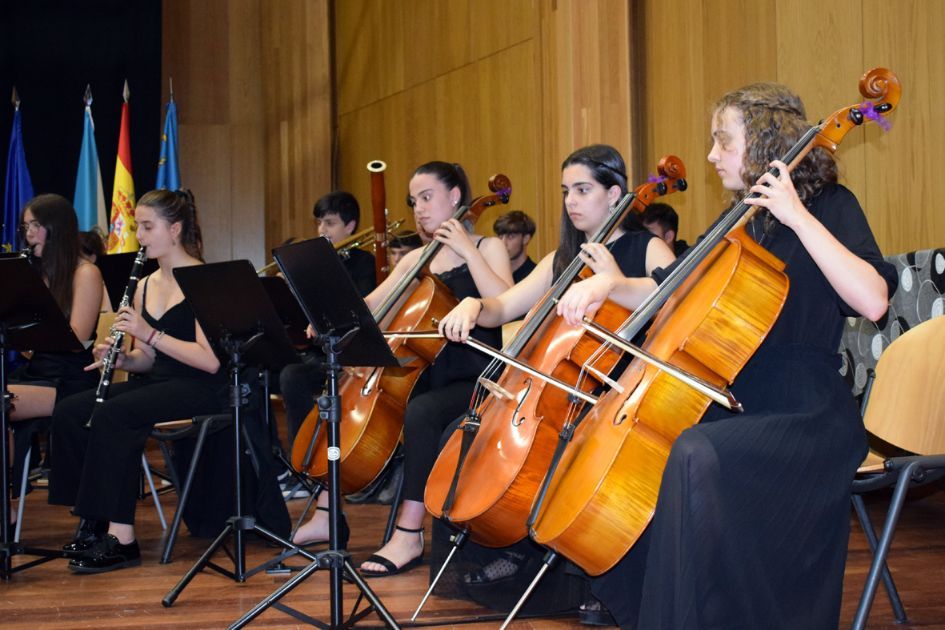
[49,190,226,573]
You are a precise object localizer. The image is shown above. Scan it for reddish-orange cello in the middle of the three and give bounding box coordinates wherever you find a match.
[424,156,687,547]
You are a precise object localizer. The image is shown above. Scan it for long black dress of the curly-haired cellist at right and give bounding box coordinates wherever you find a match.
[594,184,897,628]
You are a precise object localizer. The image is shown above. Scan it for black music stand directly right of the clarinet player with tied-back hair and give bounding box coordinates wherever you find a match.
[161,260,306,607]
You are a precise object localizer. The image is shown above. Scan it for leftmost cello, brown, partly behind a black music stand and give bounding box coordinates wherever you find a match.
[292,174,512,494]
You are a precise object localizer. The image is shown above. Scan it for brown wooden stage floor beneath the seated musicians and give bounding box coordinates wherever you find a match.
[0,452,945,629]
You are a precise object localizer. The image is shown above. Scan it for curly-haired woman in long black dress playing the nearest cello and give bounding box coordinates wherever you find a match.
[594,83,896,628]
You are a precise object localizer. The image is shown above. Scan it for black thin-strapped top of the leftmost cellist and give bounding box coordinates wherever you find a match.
[430,238,502,389]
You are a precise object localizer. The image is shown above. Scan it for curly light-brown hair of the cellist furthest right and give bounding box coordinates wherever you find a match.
[713,83,837,205]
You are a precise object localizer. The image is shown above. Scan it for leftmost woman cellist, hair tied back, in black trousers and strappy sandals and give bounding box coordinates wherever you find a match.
[294,162,512,576]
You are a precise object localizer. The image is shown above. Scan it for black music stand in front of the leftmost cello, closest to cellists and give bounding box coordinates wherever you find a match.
[230,238,399,628]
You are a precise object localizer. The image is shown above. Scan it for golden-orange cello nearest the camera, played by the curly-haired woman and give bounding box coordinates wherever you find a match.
[530,68,901,577]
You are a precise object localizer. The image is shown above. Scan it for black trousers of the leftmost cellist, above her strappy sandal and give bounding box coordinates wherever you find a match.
[403,379,475,501]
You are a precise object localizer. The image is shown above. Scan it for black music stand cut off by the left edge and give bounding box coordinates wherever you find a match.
[0,257,82,580]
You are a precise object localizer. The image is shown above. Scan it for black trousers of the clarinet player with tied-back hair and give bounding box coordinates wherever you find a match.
[49,378,226,524]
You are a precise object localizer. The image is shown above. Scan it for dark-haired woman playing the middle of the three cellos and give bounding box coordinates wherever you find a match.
[440,145,674,616]
